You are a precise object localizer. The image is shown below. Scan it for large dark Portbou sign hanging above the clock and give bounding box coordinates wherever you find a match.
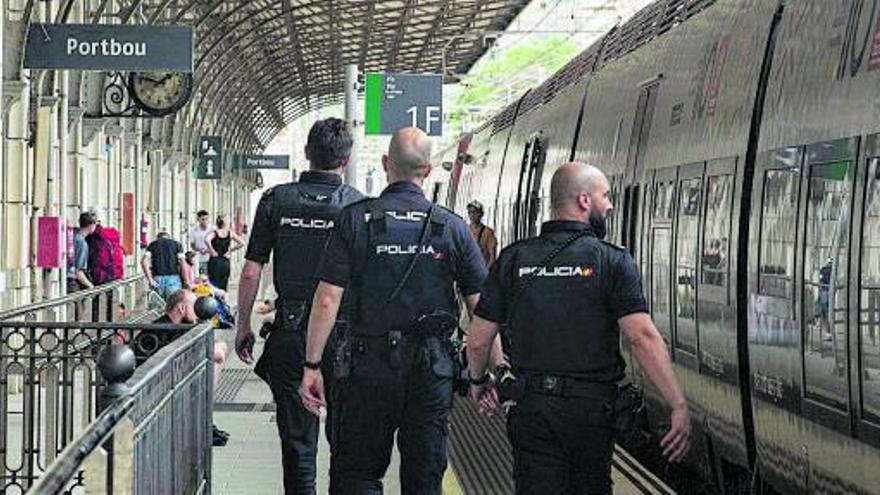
[24,24,193,72]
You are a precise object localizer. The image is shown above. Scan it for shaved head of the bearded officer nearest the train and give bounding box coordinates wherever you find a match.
[550,162,611,221]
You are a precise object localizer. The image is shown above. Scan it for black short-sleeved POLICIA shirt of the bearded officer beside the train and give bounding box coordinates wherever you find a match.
[475,220,647,382]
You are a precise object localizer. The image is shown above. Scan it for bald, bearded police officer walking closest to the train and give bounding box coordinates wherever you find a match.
[468,163,690,494]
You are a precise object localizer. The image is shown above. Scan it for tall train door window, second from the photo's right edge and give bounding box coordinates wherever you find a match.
[803,161,851,408]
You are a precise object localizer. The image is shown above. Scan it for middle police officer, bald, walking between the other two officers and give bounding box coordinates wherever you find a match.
[299,128,486,495]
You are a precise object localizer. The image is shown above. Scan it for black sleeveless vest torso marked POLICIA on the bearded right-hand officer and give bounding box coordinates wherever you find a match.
[507,231,625,382]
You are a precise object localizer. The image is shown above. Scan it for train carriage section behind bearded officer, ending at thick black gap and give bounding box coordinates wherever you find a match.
[576,0,775,484]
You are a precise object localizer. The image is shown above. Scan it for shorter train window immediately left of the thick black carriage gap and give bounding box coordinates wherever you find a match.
[700,175,733,287]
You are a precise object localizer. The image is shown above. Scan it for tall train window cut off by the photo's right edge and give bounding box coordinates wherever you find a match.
[859,158,880,423]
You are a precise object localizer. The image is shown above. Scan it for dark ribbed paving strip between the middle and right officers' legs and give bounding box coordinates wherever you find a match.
[450,396,514,495]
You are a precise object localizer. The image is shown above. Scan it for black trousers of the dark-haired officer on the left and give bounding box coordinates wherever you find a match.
[258,314,333,495]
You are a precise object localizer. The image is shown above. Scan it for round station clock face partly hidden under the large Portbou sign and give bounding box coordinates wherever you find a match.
[128,72,192,115]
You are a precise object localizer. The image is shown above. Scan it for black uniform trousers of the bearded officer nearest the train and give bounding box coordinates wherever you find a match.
[507,392,613,495]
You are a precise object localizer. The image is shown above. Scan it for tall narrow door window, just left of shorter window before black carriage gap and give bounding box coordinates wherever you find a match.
[675,179,703,355]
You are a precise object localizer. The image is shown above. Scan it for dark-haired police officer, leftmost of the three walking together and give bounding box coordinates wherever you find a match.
[235,118,363,494]
